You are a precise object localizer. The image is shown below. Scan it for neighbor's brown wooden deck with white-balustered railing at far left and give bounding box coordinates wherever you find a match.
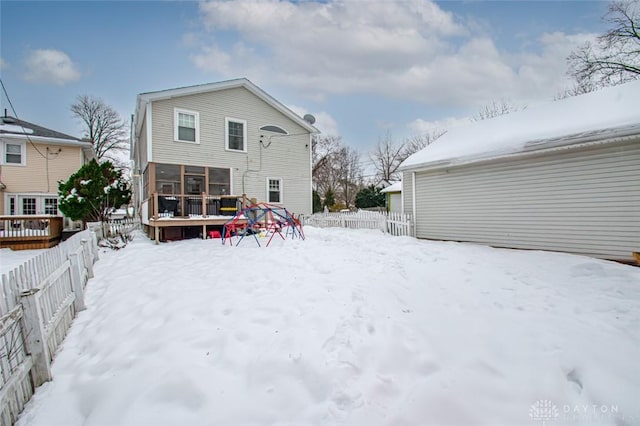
[0,215,63,250]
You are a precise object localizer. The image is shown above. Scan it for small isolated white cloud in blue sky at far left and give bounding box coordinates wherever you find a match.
[25,49,82,85]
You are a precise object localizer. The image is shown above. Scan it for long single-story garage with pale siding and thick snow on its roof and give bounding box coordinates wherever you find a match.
[401,81,640,261]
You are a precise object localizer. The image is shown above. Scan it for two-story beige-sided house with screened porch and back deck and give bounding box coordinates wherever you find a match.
[131,78,318,239]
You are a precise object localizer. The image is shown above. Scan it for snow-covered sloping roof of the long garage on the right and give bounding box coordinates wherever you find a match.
[400,80,640,170]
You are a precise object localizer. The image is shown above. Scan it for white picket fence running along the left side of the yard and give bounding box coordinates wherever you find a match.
[0,229,98,426]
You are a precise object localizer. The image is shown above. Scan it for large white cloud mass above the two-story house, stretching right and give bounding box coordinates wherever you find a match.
[191,0,596,110]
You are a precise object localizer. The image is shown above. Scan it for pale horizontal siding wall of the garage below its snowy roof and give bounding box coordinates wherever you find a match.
[412,139,640,260]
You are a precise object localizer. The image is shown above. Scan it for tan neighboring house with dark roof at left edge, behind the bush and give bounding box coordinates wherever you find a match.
[0,115,95,228]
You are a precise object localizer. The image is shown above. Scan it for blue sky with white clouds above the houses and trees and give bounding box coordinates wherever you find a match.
[0,0,607,155]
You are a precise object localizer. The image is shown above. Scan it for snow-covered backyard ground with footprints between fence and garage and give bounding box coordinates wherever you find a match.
[18,227,640,426]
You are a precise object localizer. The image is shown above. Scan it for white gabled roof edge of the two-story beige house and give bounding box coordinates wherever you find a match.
[135,78,320,133]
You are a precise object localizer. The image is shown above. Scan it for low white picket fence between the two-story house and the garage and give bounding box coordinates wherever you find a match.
[302,210,413,236]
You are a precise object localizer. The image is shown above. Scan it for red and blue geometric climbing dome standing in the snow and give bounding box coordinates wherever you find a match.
[222,203,304,247]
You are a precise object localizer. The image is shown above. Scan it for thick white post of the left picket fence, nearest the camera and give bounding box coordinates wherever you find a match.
[20,288,51,387]
